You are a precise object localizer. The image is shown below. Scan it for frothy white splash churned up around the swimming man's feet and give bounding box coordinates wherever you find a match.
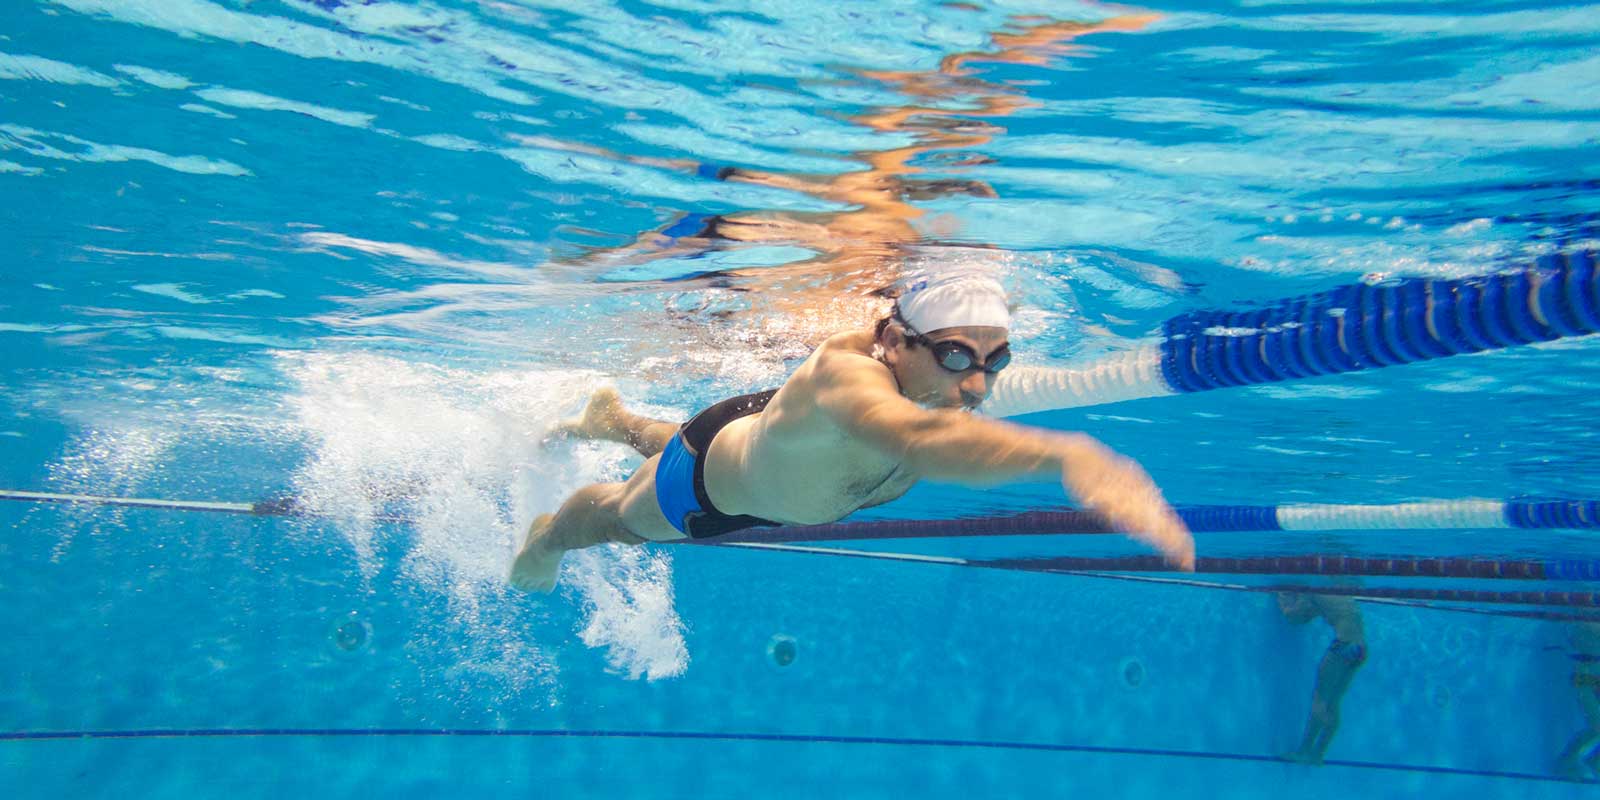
[285,354,688,680]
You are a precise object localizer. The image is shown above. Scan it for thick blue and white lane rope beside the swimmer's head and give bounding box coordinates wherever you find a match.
[982,250,1600,416]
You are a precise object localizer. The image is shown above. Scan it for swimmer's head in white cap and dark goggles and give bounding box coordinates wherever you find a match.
[877,274,1011,410]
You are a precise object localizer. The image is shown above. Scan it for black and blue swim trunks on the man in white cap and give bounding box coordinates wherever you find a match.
[656,389,781,539]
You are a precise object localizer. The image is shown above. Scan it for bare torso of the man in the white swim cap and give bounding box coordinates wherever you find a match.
[706,333,917,525]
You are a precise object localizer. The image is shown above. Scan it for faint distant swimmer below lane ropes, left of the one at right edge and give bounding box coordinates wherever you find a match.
[1277,592,1366,765]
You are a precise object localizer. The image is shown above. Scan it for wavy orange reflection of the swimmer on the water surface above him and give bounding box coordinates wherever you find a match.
[525,14,1158,334]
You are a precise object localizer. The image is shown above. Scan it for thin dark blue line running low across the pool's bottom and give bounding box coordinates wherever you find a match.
[0,728,1574,784]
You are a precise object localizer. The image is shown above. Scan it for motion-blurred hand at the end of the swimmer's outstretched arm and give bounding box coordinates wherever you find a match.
[1061,435,1195,573]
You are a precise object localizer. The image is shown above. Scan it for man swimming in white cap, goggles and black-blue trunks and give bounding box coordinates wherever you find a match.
[510,274,1194,592]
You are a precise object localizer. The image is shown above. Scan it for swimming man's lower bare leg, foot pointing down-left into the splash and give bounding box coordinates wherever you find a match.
[510,458,683,592]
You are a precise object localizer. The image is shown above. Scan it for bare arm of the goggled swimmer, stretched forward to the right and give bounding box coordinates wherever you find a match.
[813,352,1195,571]
